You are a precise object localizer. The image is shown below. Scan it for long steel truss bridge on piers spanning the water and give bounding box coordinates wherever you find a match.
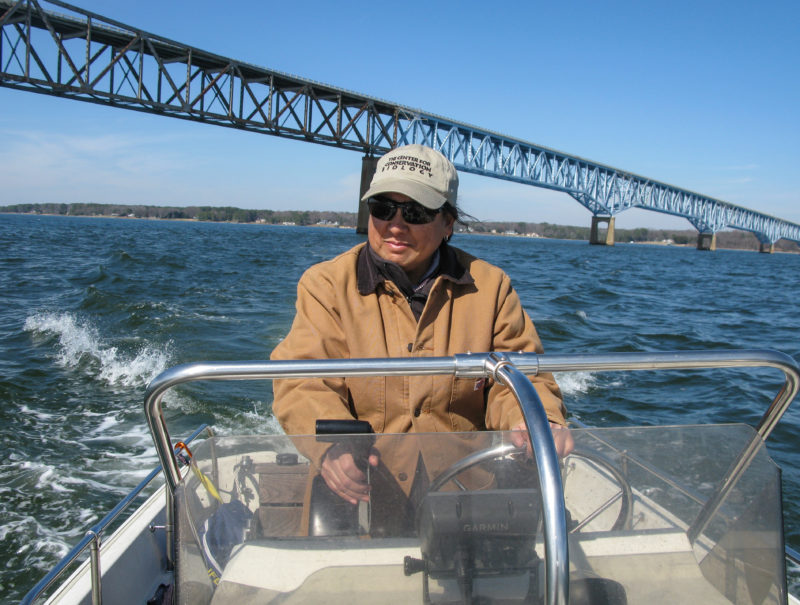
[0,0,800,252]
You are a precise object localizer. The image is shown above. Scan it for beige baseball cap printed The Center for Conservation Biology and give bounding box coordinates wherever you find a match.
[361,144,458,210]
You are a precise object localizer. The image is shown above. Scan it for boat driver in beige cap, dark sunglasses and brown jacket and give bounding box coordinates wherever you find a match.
[271,145,571,503]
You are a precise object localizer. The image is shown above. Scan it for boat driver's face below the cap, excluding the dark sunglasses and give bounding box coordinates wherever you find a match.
[368,193,455,283]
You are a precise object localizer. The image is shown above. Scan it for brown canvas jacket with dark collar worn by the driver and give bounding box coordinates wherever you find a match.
[271,244,565,442]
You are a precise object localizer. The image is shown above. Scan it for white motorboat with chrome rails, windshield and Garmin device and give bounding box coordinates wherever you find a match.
[18,350,800,605]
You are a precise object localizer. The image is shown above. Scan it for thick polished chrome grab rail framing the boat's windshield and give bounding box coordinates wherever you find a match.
[144,350,800,604]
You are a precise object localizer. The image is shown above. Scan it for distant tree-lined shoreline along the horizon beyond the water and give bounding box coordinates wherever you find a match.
[0,203,800,252]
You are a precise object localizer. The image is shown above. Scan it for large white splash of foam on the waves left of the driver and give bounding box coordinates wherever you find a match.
[25,313,170,387]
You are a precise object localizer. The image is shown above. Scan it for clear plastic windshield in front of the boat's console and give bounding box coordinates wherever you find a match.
[175,425,786,605]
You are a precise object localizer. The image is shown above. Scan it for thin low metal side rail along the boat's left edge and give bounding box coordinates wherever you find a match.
[20,424,208,605]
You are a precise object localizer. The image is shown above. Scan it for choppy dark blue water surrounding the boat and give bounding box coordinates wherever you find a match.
[0,215,800,601]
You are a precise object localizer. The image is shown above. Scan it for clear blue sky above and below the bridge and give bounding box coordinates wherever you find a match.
[0,0,800,229]
